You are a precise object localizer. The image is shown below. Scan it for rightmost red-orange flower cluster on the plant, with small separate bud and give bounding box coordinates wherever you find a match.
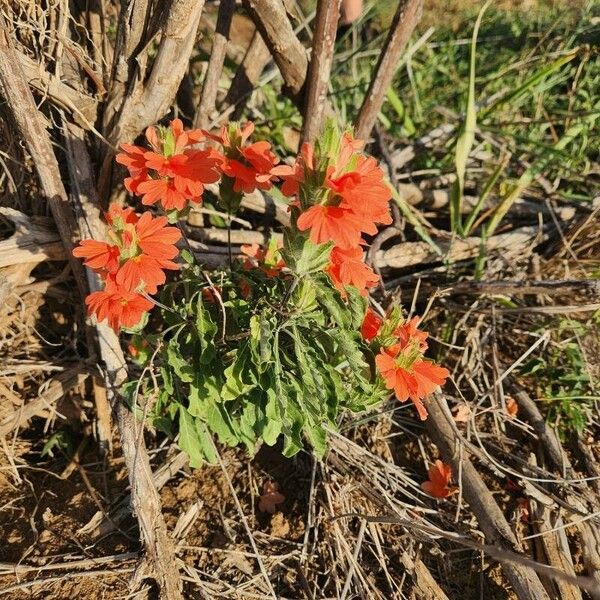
[361,309,449,421]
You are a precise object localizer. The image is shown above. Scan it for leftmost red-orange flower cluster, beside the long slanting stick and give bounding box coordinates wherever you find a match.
[73,205,181,331]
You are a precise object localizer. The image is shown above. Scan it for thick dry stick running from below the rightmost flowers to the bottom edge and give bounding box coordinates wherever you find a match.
[425,394,549,600]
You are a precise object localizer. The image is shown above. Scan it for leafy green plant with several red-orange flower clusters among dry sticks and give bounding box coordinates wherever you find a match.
[74,120,448,466]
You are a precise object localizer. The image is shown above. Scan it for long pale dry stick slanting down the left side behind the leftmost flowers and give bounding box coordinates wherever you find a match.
[0,22,182,600]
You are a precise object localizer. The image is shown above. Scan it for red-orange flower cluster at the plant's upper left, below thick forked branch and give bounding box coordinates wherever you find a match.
[117,119,223,210]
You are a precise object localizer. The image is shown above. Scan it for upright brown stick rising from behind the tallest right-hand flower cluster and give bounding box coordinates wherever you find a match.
[302,0,341,142]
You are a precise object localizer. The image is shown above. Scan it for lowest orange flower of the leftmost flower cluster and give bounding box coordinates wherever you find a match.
[85,283,152,332]
